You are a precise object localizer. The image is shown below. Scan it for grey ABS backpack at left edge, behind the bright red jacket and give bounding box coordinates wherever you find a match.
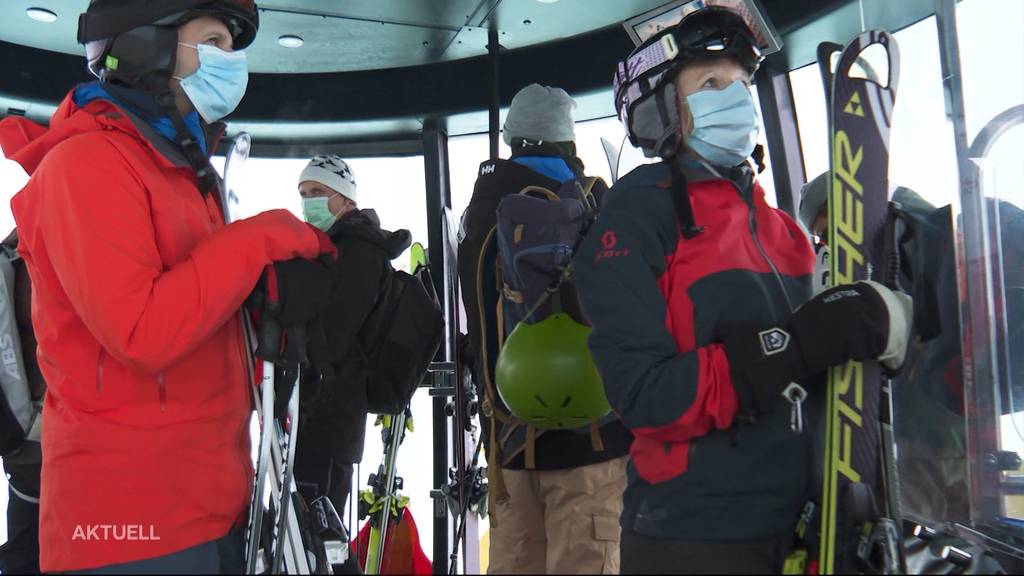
[0,234,42,457]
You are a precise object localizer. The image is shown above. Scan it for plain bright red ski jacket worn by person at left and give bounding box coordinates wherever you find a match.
[0,87,318,572]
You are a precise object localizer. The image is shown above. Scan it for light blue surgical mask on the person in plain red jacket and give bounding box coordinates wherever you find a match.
[174,42,249,123]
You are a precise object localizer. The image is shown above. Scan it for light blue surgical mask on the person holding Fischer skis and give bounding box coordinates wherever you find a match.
[686,80,758,167]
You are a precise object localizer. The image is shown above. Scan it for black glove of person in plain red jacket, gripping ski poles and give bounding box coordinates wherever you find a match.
[247,258,335,380]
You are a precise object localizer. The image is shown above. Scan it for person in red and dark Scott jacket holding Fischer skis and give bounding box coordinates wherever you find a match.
[574,8,908,574]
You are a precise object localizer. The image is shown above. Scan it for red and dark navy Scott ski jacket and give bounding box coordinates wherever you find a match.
[574,159,813,540]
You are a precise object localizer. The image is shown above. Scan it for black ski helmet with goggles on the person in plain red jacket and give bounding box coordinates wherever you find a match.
[78,0,259,91]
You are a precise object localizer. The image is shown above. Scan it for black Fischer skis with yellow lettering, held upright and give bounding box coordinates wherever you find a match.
[818,31,905,574]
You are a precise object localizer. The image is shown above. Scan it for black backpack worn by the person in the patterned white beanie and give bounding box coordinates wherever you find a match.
[357,263,444,414]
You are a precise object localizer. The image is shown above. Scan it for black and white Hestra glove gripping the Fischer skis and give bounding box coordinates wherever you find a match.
[722,282,913,416]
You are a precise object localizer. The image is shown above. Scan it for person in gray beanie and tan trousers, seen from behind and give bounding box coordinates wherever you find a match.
[458,84,633,574]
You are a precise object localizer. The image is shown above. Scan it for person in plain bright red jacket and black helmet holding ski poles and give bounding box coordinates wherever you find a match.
[0,0,330,573]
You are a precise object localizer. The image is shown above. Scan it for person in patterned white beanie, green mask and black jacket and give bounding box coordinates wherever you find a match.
[295,155,412,574]
